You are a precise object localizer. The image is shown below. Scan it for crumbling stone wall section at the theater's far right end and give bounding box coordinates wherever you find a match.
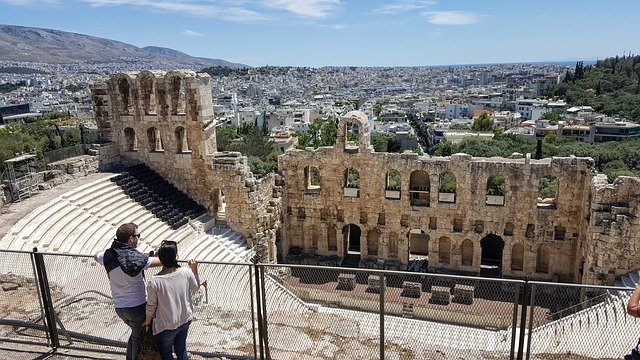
[580,175,640,285]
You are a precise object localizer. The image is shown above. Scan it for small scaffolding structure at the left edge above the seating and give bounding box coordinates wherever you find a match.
[3,154,38,202]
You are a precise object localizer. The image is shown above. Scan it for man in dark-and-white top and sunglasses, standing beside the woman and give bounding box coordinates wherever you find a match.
[94,223,162,360]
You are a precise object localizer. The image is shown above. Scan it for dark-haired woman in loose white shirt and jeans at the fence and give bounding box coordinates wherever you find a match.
[145,240,200,360]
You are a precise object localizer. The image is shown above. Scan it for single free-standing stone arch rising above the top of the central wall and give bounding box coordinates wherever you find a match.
[337,111,372,153]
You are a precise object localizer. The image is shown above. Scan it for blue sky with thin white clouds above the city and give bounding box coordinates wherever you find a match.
[0,0,640,67]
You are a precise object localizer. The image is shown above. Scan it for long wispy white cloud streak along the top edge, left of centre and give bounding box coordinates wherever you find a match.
[82,0,269,23]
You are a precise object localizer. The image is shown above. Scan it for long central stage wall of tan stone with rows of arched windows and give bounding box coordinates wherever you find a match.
[279,111,593,281]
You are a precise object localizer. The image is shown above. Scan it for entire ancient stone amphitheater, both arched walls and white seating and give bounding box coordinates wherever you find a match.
[0,71,640,359]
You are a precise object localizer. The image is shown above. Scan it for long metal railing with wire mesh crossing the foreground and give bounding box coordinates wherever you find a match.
[0,251,640,359]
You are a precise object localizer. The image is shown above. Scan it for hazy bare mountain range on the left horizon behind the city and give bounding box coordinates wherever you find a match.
[0,24,249,70]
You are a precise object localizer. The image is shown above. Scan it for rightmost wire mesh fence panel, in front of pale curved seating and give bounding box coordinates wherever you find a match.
[526,282,640,360]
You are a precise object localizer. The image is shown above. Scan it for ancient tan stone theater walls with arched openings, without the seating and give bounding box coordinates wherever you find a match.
[92,71,640,284]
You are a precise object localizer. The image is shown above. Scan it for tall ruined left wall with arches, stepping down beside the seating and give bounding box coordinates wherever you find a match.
[92,71,279,261]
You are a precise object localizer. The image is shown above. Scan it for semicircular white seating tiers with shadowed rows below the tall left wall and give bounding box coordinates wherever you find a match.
[0,165,251,262]
